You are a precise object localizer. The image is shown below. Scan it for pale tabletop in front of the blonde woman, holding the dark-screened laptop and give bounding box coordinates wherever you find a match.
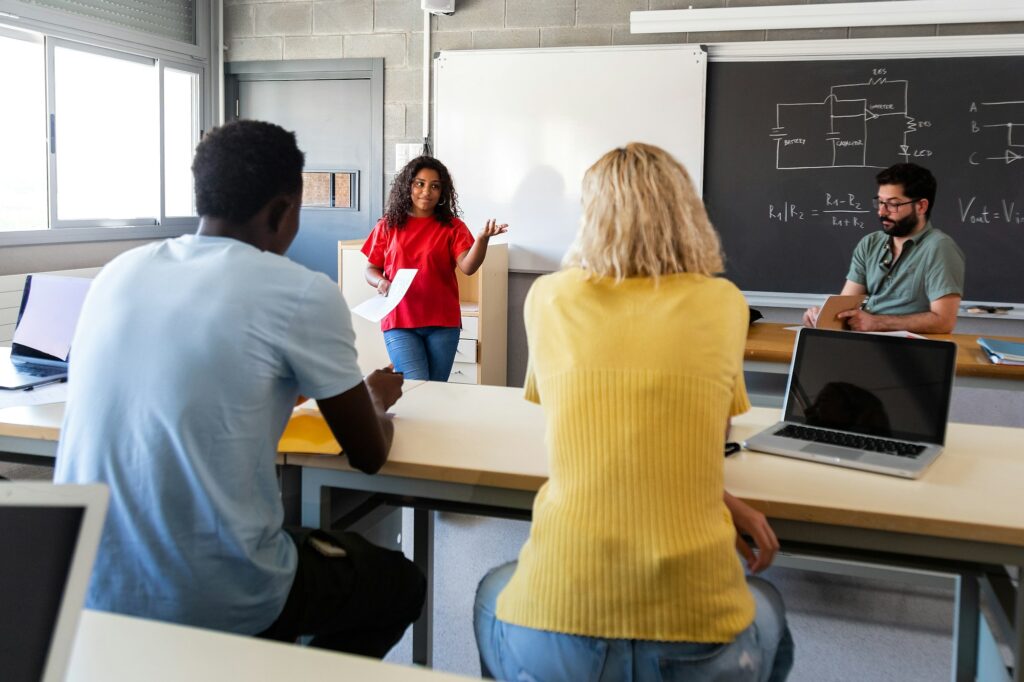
[288,383,1024,548]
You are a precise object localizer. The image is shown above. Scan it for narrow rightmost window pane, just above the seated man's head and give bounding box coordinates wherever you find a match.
[164,69,199,216]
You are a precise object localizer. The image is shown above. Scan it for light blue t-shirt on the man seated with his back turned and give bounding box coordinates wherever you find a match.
[54,236,362,634]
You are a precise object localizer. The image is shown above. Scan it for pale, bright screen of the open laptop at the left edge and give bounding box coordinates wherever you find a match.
[12,274,92,359]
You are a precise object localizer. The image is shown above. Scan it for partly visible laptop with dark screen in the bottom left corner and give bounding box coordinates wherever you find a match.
[0,481,109,682]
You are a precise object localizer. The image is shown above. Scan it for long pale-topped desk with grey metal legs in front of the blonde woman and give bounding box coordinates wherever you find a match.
[288,383,1024,680]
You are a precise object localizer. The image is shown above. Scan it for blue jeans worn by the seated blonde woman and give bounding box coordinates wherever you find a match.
[473,562,794,682]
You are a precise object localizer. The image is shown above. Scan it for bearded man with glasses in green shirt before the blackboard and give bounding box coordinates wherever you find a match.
[804,164,964,334]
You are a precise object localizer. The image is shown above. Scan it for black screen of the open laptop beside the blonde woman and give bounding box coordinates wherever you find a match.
[784,329,956,444]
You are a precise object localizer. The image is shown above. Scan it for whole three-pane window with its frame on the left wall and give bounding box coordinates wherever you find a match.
[0,0,213,245]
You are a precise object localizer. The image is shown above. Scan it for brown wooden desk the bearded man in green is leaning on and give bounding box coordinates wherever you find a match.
[743,322,1024,406]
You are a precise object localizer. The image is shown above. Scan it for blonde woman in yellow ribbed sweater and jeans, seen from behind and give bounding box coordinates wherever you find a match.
[474,143,793,682]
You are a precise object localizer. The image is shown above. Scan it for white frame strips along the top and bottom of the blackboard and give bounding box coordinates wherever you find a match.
[707,34,1024,307]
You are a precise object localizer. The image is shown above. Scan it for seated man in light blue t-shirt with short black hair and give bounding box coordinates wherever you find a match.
[54,121,425,656]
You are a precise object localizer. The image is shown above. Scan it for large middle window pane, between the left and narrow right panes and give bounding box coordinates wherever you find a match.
[53,46,160,220]
